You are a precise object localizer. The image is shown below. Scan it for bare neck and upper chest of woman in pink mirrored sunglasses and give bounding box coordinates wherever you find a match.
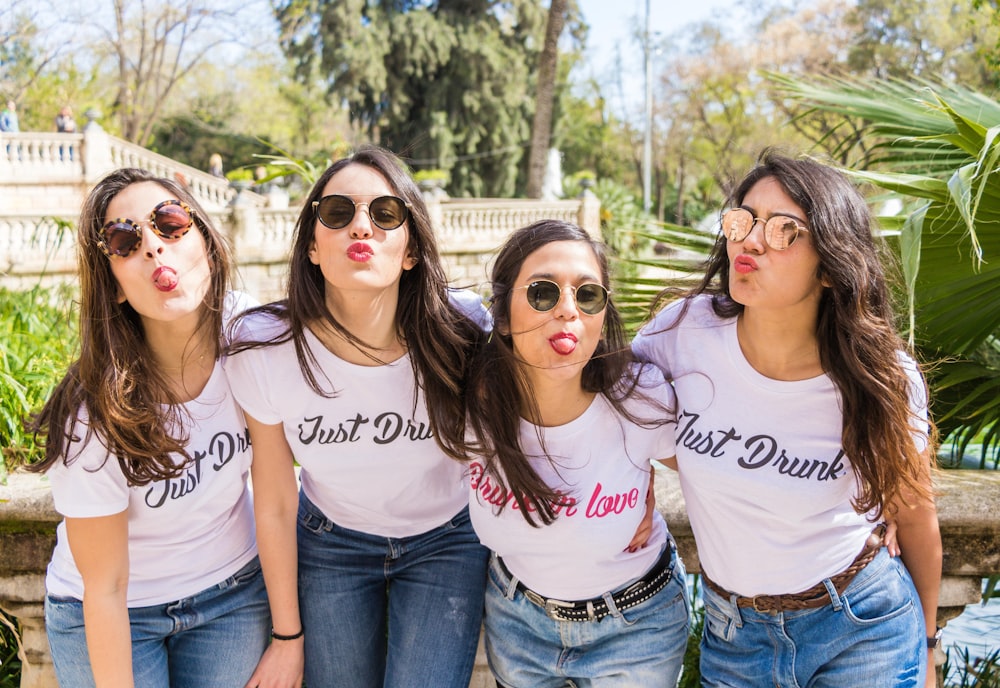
[736,308,823,381]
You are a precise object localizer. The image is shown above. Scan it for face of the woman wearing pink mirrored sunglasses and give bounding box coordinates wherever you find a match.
[726,177,823,311]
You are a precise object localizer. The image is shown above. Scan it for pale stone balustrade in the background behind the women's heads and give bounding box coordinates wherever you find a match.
[0,121,600,301]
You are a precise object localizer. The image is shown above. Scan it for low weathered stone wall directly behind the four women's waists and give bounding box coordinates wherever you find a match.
[0,470,1000,688]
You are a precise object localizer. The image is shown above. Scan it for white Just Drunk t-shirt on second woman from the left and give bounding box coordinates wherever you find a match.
[226,314,468,537]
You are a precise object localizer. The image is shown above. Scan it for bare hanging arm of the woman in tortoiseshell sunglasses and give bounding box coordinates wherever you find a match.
[66,511,134,688]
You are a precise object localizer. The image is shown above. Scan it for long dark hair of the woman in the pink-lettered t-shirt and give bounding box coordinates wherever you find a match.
[455,220,670,526]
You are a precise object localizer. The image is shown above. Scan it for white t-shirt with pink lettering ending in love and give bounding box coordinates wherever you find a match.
[469,367,674,600]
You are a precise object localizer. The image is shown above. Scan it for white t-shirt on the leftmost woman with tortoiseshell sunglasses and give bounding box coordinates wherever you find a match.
[45,362,257,607]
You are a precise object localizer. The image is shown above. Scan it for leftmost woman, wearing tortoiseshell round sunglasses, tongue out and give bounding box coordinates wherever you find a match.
[29,169,270,688]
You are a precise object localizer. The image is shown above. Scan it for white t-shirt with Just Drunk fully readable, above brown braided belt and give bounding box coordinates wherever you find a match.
[633,295,926,596]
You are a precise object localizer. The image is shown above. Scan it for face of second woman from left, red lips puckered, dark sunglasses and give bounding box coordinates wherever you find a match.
[309,164,416,298]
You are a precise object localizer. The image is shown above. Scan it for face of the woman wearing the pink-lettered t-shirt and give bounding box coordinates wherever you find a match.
[510,241,605,379]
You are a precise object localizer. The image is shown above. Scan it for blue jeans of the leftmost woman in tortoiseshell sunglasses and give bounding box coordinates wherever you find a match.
[45,557,271,688]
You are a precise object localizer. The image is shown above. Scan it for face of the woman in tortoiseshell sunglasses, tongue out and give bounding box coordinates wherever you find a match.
[104,182,212,322]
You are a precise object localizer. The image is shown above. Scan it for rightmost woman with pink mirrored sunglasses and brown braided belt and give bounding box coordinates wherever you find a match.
[634,151,941,688]
